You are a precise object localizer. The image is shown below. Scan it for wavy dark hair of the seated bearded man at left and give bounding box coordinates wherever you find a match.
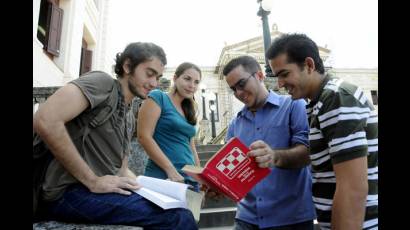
[114,42,167,78]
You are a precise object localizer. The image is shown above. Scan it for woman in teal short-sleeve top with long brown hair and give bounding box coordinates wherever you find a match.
[137,62,201,190]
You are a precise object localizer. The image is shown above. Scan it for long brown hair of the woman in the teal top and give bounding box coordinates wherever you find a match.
[173,62,202,125]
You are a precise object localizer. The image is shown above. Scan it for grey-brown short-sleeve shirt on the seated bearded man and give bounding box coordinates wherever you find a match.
[43,71,135,201]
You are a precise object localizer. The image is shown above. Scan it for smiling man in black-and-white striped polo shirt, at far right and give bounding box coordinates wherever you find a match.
[257,34,378,230]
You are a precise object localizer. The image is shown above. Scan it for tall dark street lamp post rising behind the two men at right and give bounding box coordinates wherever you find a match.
[257,0,272,77]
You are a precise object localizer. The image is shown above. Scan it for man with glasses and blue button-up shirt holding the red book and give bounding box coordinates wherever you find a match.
[223,56,316,230]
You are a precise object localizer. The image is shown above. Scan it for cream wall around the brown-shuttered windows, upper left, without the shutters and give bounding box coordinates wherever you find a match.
[33,0,111,87]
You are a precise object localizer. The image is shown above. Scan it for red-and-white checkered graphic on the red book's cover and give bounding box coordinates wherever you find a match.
[216,147,251,179]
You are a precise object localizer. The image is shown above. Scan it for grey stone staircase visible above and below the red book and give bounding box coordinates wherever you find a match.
[196,144,236,229]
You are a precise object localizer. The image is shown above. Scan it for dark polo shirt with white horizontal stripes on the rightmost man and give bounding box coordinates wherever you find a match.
[306,76,378,229]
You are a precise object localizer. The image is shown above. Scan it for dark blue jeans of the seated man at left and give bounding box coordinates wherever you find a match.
[48,184,198,229]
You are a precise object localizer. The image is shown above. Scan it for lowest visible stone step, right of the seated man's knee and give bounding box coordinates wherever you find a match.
[198,207,236,228]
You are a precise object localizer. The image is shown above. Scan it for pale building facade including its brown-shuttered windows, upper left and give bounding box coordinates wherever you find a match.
[33,0,111,87]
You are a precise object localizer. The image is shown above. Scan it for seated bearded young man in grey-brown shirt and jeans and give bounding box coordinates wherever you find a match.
[33,42,197,229]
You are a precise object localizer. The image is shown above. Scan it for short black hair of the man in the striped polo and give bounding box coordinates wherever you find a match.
[266,33,325,74]
